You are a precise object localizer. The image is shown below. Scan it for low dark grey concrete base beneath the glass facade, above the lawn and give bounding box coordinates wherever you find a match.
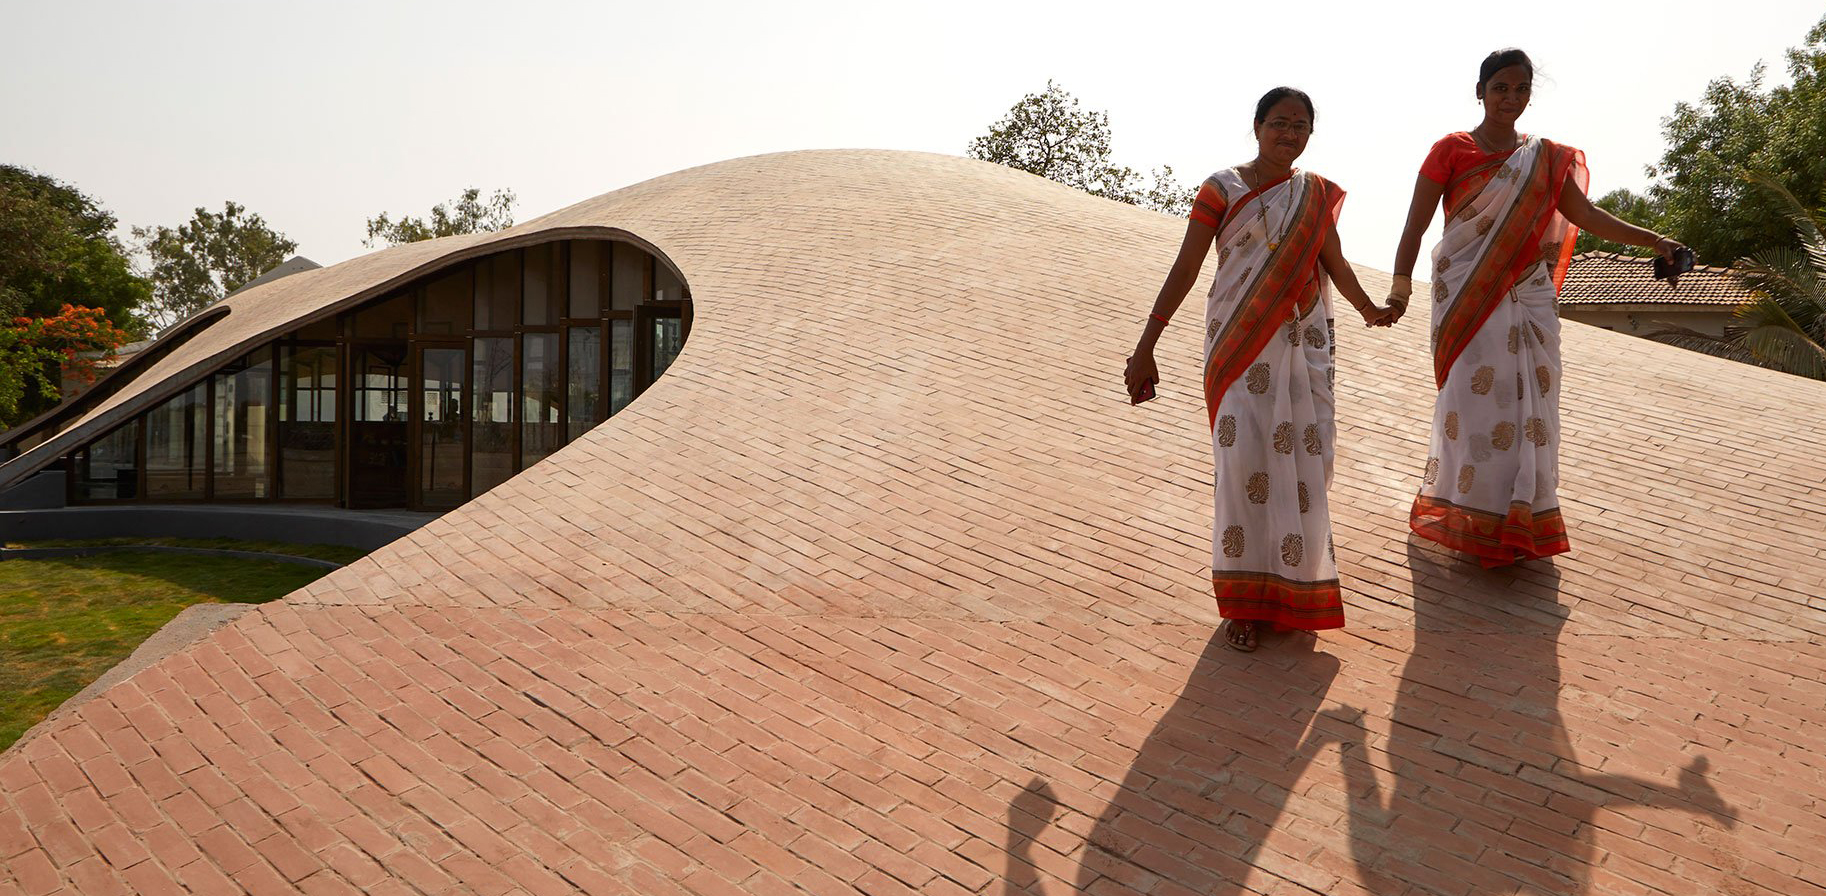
[0,504,436,551]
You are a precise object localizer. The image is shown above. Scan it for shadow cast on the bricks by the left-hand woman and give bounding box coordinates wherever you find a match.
[1002,635,1338,896]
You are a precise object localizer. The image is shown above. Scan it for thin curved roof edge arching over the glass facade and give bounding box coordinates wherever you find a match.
[0,215,690,489]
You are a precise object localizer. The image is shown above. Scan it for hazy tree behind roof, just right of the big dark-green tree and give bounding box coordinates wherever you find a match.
[133,201,298,328]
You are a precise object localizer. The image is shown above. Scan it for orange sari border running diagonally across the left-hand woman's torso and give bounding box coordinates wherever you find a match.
[1205,173,1344,427]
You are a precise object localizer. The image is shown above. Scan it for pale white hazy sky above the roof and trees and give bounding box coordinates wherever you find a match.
[0,0,1826,274]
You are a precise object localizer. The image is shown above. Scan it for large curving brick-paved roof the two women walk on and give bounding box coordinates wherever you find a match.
[0,151,1826,896]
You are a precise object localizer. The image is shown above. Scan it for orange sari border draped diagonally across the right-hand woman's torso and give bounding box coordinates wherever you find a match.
[1433,141,1583,389]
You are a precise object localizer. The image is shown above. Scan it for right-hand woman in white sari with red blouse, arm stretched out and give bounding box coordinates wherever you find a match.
[1390,49,1684,566]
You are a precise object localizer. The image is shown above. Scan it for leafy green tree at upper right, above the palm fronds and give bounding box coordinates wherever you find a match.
[1579,18,1826,265]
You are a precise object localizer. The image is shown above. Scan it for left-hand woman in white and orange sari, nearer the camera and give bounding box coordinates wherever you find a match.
[1125,88,1399,650]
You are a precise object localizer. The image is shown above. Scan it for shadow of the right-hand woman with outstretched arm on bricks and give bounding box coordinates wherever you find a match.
[1300,538,1737,896]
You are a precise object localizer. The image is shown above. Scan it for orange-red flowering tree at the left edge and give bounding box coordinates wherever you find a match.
[0,305,130,429]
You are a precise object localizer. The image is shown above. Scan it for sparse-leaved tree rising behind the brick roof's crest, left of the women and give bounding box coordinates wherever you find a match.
[966,80,1194,215]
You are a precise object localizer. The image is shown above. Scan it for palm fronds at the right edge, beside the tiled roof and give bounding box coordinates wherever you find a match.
[1647,173,1826,380]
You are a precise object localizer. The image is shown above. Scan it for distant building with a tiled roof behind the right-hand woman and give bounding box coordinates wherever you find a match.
[1559,252,1751,336]
